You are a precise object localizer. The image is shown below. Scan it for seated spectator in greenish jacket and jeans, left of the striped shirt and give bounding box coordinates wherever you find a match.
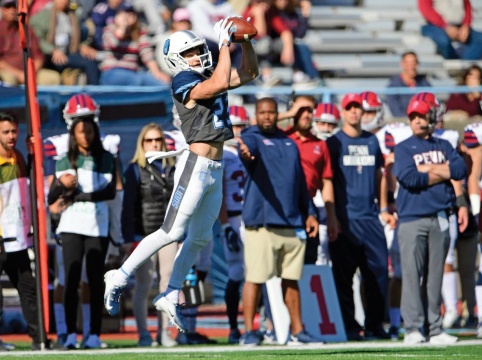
[30,0,99,85]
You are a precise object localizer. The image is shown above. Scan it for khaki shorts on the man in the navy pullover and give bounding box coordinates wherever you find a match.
[244,228,306,284]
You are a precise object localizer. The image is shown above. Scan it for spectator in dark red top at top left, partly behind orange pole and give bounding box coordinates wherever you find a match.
[0,0,60,85]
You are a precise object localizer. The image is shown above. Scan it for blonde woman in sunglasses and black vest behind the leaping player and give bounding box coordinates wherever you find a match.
[121,123,177,347]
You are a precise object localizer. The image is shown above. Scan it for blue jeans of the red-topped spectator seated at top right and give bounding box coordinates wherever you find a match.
[422,24,482,60]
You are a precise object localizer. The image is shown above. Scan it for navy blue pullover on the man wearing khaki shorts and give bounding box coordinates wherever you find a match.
[240,126,316,228]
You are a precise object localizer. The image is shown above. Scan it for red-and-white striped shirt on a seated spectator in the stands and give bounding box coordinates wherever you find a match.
[99,24,154,71]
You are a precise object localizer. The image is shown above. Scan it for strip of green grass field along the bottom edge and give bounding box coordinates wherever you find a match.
[0,340,482,360]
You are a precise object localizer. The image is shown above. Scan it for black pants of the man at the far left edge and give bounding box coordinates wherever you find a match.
[0,249,40,343]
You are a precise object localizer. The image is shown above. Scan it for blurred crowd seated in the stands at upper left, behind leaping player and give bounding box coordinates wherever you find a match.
[0,0,320,87]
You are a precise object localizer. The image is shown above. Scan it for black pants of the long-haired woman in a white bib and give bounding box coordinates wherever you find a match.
[60,233,109,335]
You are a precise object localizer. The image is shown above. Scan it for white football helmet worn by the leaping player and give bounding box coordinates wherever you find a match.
[162,30,213,74]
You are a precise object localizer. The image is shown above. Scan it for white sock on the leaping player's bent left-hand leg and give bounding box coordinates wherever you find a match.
[114,229,174,286]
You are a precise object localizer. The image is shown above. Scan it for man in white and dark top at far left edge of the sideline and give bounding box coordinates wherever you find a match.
[0,112,47,350]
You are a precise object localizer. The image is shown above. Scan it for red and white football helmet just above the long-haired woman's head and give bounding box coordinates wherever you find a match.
[63,94,100,130]
